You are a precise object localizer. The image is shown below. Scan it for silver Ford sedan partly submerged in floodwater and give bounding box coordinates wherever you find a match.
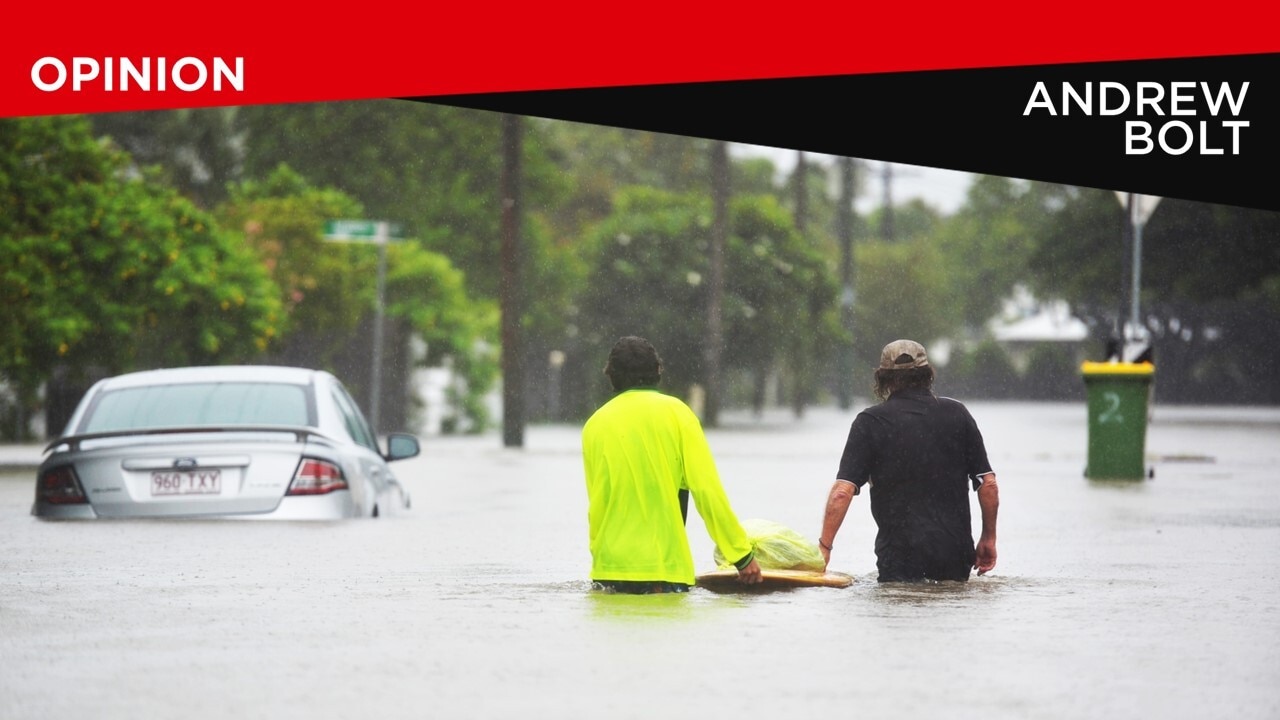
[31,365,420,520]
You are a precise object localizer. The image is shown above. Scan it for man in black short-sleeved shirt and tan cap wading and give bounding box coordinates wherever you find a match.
[818,340,1000,583]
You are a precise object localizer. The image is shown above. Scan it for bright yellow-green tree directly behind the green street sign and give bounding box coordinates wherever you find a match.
[219,165,497,428]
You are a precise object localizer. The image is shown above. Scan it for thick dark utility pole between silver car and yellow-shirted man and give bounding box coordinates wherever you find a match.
[499,114,525,447]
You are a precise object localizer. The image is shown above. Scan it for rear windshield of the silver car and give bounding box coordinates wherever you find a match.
[79,382,310,433]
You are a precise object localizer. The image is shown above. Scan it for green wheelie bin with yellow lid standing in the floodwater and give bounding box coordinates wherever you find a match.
[1080,363,1156,480]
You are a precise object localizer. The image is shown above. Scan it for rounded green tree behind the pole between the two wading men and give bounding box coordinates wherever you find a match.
[581,187,835,407]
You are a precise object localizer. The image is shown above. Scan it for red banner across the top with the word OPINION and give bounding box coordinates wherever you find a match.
[0,0,1280,117]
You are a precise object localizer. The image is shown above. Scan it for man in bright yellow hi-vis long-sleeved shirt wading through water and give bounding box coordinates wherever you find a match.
[582,336,760,593]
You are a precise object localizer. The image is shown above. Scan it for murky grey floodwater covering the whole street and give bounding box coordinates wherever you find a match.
[0,402,1280,720]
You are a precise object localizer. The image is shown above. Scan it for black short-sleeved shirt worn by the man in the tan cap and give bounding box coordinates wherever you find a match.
[836,389,992,582]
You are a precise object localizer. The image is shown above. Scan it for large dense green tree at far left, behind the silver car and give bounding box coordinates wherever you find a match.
[0,115,282,438]
